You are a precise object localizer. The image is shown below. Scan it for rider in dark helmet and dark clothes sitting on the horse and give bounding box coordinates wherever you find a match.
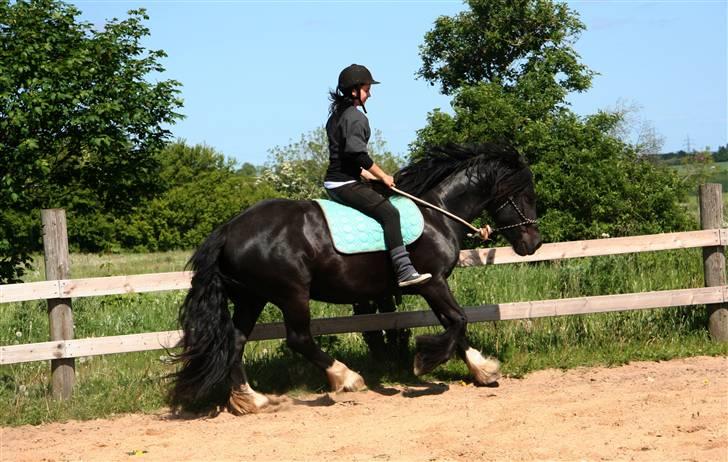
[324,64,432,287]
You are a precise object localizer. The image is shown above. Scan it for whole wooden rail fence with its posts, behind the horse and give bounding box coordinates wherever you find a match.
[0,184,728,398]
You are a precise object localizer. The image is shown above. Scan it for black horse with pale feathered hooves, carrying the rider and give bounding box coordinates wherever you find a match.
[170,144,541,413]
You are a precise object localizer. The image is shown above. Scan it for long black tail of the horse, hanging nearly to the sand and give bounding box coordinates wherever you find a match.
[169,225,235,410]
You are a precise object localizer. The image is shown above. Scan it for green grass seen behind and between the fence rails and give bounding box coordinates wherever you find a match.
[0,249,728,425]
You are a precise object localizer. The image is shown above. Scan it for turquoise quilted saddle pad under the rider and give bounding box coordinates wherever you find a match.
[316,196,425,254]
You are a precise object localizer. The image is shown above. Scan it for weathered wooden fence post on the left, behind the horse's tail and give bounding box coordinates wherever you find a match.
[41,209,76,399]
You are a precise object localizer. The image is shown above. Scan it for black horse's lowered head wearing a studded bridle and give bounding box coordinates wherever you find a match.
[487,163,542,256]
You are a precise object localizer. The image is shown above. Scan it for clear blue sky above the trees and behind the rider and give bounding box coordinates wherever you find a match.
[70,0,728,164]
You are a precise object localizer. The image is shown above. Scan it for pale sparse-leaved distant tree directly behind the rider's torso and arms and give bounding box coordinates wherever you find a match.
[259,127,400,199]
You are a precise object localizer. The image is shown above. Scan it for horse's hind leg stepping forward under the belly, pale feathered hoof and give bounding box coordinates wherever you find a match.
[280,294,366,391]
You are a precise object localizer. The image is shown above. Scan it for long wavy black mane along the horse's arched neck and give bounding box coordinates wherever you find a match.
[395,143,527,196]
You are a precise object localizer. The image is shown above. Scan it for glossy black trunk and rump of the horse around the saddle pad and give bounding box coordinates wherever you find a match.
[216,199,393,304]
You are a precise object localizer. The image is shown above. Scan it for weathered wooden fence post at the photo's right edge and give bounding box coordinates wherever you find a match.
[699,183,728,342]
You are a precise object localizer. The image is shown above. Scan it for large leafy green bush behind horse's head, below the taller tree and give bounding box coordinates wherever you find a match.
[413,84,694,242]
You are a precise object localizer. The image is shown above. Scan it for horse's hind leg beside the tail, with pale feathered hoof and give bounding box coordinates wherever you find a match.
[228,293,270,415]
